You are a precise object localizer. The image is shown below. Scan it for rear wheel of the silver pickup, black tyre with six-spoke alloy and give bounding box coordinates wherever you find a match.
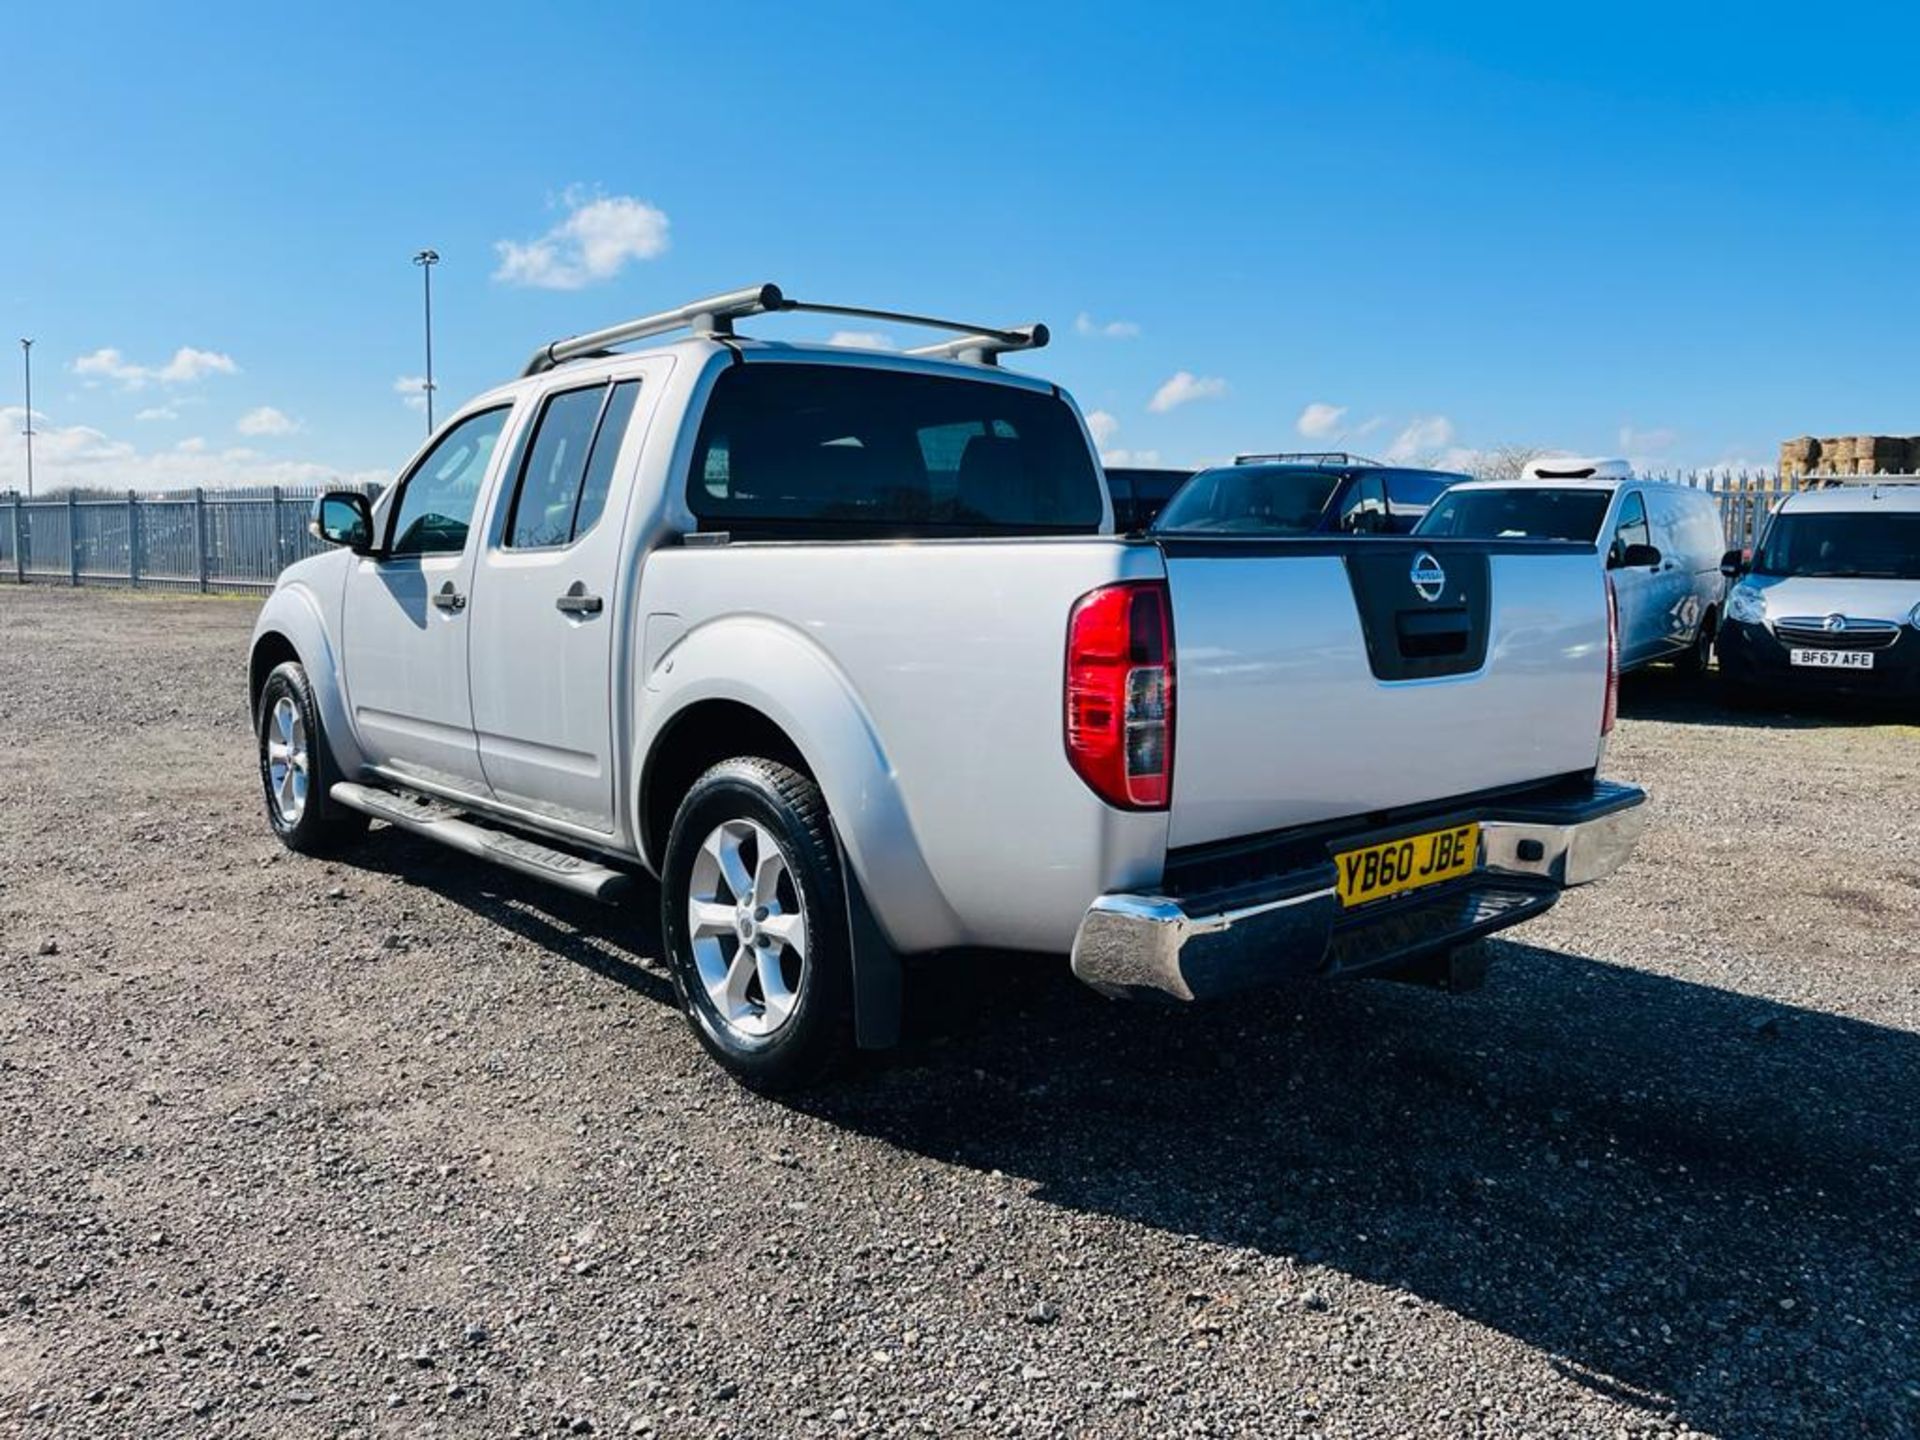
[660,758,852,1091]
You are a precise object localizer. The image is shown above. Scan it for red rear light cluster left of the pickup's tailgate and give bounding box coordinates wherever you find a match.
[1066,580,1173,810]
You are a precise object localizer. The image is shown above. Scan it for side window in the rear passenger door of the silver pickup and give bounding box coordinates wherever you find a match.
[503,380,639,549]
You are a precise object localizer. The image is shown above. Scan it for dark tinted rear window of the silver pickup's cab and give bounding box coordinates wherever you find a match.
[687,361,1104,540]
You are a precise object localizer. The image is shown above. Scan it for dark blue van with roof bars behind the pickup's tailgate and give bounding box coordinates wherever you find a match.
[1154,451,1469,536]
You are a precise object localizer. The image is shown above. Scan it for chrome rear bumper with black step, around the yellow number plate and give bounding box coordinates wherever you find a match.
[1073,781,1647,1000]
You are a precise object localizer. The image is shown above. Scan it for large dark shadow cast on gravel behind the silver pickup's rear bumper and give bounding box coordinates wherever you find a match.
[801,945,1920,1438]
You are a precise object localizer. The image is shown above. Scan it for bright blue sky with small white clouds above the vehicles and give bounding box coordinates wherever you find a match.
[0,0,1920,488]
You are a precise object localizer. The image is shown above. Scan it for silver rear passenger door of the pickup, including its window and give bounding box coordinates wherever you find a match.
[468,372,659,835]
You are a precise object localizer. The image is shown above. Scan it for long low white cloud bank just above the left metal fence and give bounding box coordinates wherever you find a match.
[0,407,392,490]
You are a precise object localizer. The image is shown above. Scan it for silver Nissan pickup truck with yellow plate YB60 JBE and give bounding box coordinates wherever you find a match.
[250,286,1644,1087]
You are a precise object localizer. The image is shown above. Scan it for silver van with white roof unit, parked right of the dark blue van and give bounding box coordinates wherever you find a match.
[1413,474,1726,674]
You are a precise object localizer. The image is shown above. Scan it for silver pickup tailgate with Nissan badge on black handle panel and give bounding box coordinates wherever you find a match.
[1162,536,1607,847]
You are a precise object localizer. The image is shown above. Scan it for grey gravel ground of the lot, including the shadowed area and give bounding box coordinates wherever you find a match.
[0,588,1920,1436]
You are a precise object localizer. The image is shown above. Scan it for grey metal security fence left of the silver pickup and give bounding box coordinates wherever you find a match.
[0,486,378,591]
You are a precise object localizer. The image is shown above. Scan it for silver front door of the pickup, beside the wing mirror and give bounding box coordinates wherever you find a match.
[340,405,511,795]
